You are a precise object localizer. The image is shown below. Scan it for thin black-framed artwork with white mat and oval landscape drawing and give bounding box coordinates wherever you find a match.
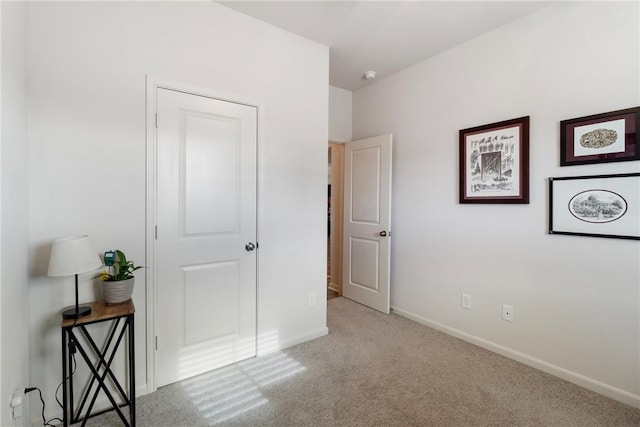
[549,173,640,240]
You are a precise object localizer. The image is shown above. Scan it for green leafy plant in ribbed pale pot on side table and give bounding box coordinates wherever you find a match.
[96,249,142,305]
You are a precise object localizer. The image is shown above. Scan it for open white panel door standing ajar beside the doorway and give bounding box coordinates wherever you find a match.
[342,134,393,313]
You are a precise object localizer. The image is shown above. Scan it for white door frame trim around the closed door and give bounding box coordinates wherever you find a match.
[146,75,266,394]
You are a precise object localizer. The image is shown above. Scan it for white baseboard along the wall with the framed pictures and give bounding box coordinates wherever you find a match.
[391,307,640,409]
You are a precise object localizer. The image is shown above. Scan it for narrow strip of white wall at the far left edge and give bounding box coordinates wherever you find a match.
[0,2,30,426]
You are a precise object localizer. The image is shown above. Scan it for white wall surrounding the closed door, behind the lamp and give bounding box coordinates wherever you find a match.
[28,2,328,420]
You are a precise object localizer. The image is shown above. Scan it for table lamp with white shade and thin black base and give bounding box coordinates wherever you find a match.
[48,236,102,319]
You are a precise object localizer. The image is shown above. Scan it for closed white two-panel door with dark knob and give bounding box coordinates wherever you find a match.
[156,89,257,386]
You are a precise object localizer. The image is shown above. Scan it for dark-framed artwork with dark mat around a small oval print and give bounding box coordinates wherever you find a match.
[560,107,640,166]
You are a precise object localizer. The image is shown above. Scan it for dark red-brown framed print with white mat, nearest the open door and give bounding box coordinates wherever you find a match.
[460,116,529,204]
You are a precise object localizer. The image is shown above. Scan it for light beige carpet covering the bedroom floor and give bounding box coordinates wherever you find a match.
[87,298,640,427]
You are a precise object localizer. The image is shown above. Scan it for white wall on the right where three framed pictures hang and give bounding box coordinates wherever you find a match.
[353,2,640,406]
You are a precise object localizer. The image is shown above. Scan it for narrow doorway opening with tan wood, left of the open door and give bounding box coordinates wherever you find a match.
[327,142,344,299]
